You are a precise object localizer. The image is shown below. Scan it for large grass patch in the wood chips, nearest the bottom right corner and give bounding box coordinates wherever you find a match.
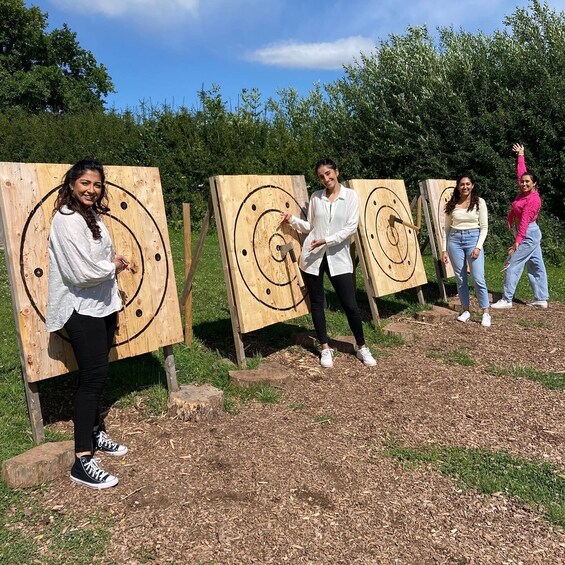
[384,446,565,527]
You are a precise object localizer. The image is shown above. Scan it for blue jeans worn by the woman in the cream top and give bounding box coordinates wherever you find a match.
[447,228,489,309]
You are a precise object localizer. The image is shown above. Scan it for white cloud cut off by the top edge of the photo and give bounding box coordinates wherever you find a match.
[52,0,200,22]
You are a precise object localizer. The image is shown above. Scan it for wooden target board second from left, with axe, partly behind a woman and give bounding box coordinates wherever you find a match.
[210,175,309,334]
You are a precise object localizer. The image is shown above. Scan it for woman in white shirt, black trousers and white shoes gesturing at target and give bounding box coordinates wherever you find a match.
[281,159,377,367]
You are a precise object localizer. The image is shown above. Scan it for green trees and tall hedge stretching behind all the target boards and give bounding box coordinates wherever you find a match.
[0,0,565,263]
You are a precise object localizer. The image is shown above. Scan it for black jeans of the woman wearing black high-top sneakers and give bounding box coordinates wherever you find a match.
[65,312,118,453]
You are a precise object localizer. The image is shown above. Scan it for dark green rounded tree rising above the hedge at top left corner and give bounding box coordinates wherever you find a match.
[0,0,114,113]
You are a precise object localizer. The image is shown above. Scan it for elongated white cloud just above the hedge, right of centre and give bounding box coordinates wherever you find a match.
[246,36,375,70]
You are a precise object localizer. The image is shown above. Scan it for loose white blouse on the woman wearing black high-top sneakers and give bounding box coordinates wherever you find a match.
[45,207,122,332]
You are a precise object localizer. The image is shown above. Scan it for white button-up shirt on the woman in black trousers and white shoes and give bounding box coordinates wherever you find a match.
[289,185,359,276]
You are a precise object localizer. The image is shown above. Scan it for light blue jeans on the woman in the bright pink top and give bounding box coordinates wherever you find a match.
[504,222,549,301]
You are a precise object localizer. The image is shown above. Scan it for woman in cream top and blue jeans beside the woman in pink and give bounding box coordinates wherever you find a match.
[441,174,491,327]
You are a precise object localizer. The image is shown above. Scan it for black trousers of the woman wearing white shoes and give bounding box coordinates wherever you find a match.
[302,255,365,345]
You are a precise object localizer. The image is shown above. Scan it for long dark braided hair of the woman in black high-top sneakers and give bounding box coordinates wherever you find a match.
[53,158,110,239]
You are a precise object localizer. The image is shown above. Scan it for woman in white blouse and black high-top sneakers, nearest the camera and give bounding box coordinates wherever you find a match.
[46,159,128,489]
